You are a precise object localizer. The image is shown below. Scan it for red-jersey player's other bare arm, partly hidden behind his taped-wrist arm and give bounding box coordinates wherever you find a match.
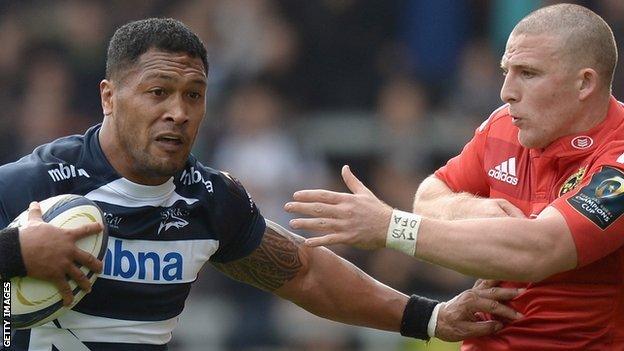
[414,175,525,220]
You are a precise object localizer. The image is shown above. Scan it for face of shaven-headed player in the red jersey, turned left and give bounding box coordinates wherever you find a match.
[501,33,580,148]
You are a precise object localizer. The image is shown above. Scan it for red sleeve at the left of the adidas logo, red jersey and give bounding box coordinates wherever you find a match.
[435,121,490,197]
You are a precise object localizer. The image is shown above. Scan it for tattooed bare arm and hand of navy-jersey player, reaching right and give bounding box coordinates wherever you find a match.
[213,222,519,341]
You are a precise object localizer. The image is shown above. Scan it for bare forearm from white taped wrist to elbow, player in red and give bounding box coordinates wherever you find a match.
[416,213,576,281]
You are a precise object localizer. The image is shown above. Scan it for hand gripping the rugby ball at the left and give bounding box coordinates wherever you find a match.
[19,202,103,306]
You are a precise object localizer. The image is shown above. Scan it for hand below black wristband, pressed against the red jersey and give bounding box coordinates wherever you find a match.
[435,281,524,341]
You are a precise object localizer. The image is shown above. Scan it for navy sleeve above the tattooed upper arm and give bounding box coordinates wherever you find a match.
[210,172,266,263]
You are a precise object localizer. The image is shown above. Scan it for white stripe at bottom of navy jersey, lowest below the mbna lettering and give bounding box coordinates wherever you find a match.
[28,311,179,351]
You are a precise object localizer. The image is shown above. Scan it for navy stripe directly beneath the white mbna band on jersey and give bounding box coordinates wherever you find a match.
[73,278,191,321]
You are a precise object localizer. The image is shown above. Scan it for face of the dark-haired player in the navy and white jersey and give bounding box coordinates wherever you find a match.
[105,50,206,184]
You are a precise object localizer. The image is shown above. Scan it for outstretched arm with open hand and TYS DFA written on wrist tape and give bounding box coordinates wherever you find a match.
[285,168,577,281]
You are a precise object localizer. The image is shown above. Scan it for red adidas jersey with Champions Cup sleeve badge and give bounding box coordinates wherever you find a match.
[436,97,624,351]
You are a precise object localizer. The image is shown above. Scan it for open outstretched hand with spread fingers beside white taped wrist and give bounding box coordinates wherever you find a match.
[284,166,392,249]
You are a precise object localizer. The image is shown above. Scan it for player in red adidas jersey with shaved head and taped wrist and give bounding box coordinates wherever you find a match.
[285,4,624,350]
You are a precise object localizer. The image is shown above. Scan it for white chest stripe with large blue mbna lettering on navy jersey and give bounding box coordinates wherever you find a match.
[98,237,219,284]
